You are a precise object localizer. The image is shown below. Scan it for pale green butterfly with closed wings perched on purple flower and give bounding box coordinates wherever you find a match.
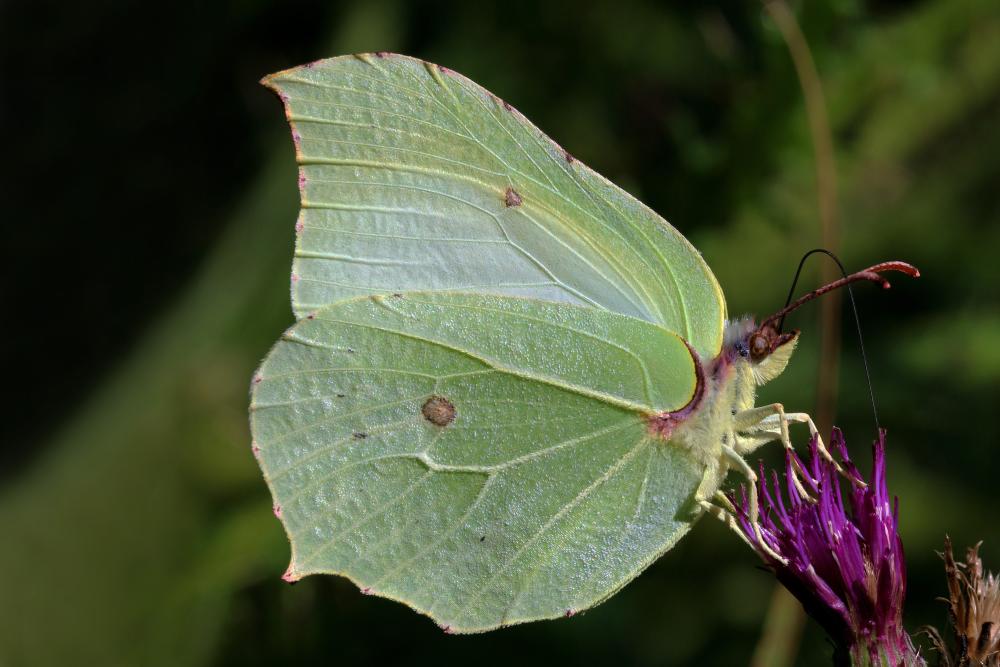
[250,53,916,632]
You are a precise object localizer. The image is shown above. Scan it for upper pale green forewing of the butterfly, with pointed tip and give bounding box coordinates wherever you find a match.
[264,54,725,357]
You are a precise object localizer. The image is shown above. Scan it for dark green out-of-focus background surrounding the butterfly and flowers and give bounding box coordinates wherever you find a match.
[0,0,1000,667]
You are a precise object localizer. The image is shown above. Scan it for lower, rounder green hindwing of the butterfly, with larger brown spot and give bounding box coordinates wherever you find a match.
[251,292,703,632]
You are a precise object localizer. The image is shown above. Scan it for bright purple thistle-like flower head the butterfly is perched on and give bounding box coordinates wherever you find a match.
[730,429,924,667]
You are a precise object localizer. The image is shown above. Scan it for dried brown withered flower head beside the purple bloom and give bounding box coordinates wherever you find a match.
[925,537,1000,667]
